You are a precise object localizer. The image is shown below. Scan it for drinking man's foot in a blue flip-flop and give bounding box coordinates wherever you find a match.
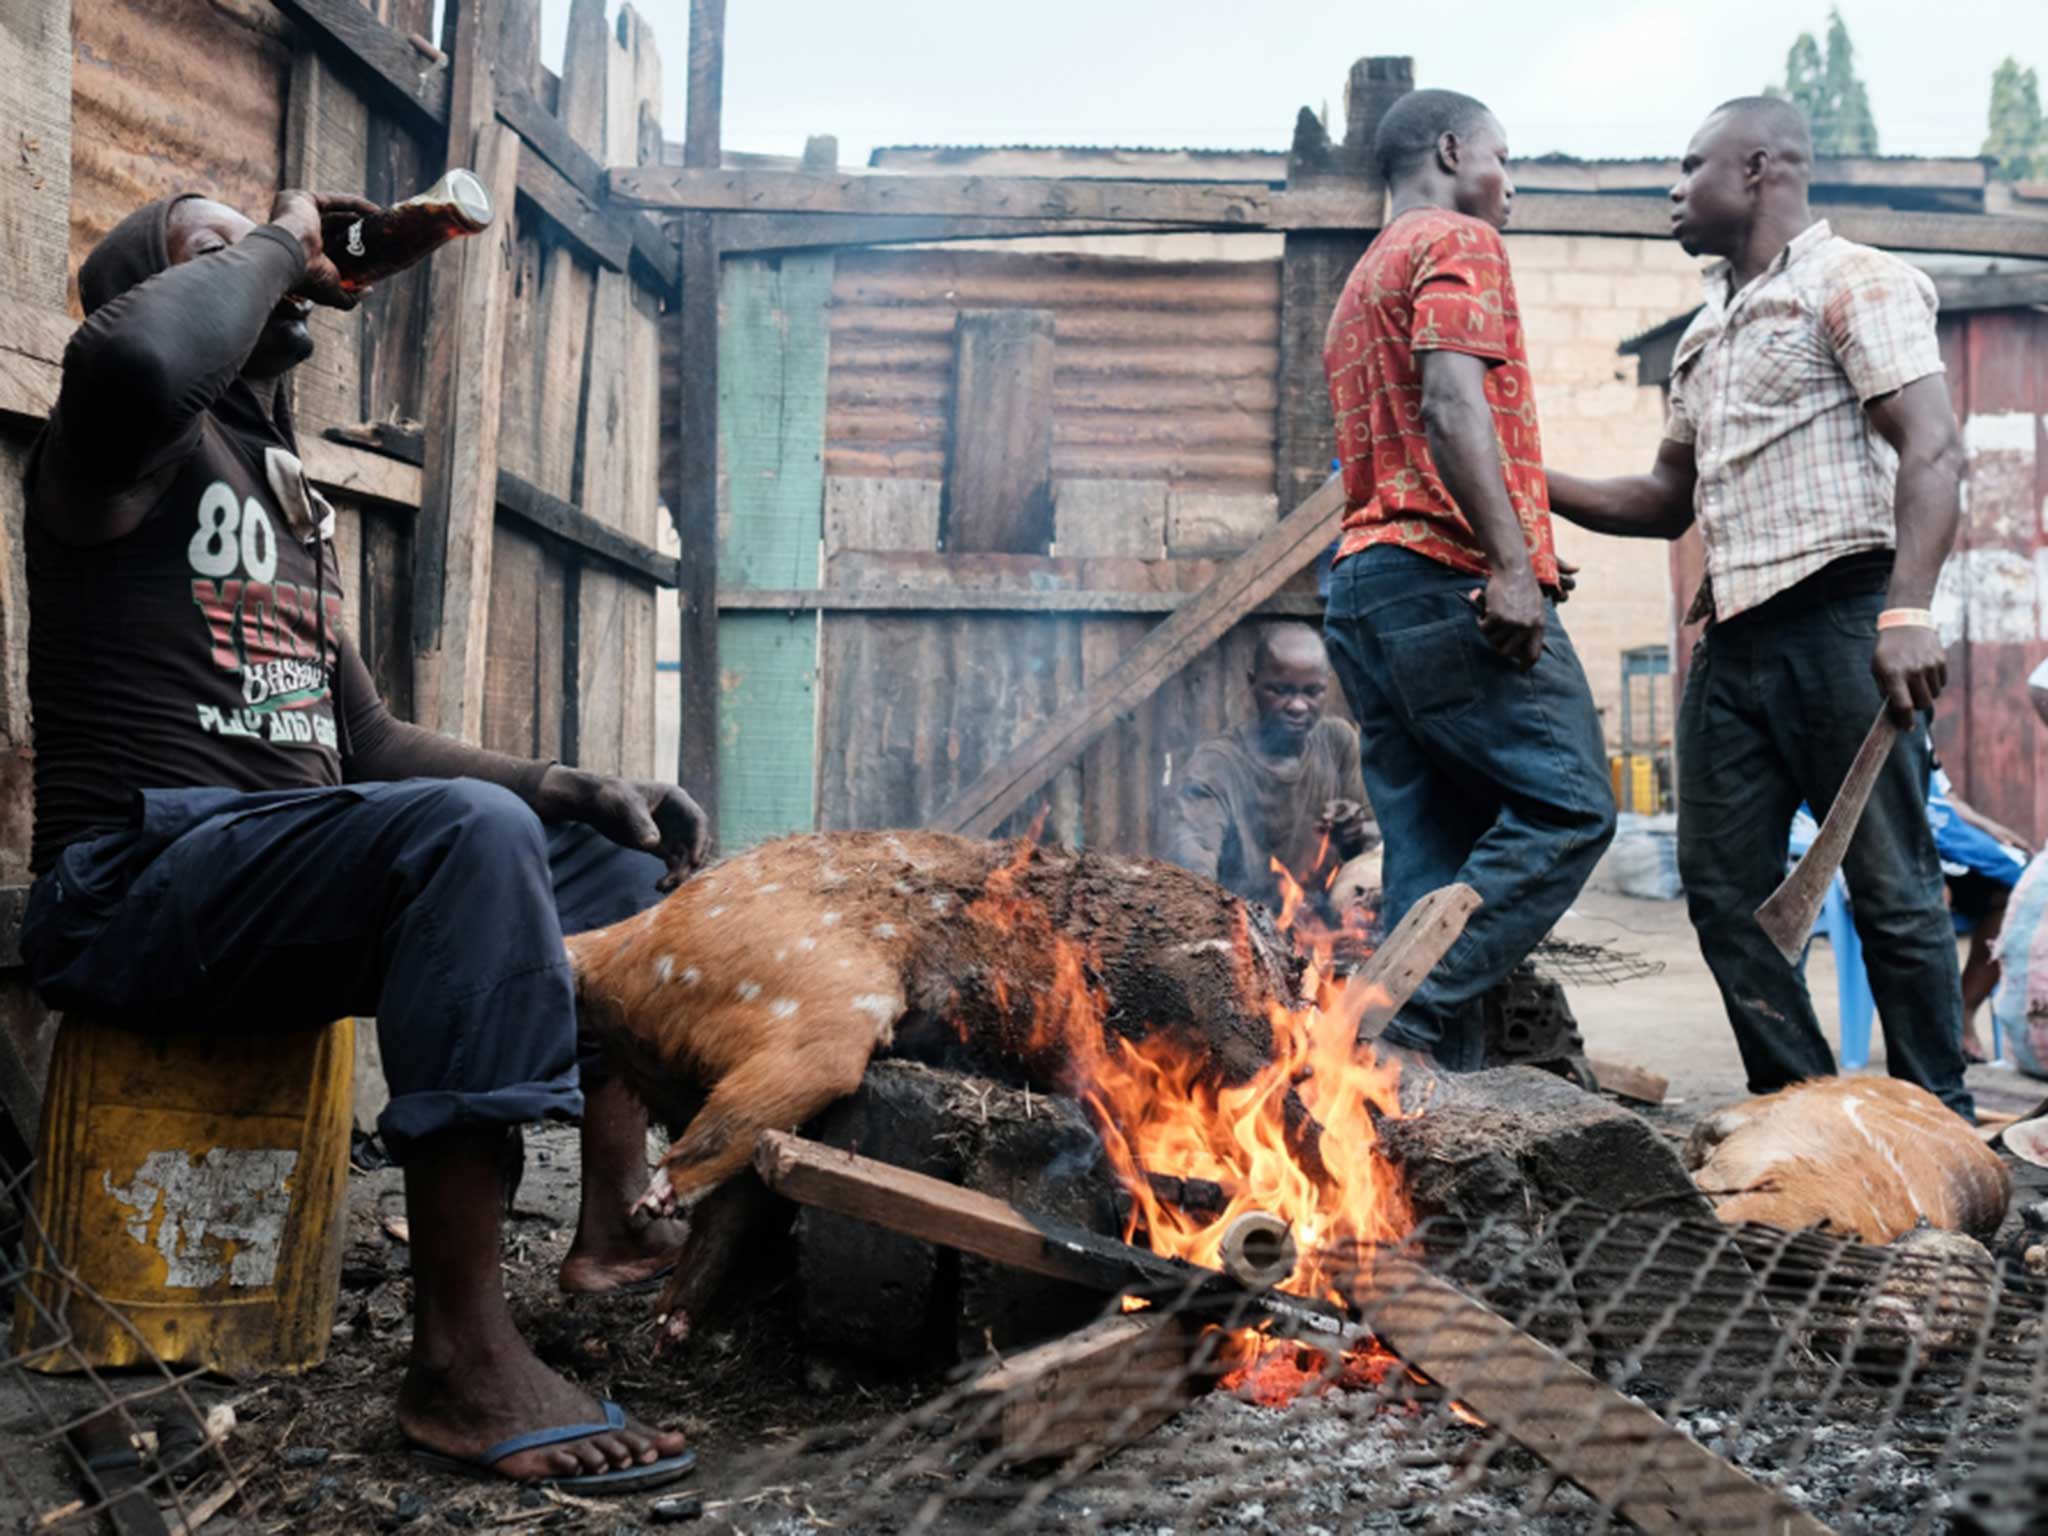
[397,1343,688,1483]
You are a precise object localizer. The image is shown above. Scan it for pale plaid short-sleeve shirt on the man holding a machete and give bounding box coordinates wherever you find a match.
[1665,219,1942,618]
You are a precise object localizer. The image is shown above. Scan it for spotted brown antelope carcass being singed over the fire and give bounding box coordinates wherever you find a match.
[569,831,1313,1214]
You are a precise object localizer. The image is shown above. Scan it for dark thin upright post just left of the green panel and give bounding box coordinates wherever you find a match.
[668,0,725,836]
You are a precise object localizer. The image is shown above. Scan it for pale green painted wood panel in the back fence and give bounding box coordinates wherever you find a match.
[719,252,834,852]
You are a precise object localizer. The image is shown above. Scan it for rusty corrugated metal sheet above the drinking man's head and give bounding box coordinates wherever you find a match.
[72,0,290,307]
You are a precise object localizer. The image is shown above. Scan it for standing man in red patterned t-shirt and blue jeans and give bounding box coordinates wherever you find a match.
[1323,90,1614,1071]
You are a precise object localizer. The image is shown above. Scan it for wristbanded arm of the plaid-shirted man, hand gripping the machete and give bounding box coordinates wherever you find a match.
[1864,373,1962,731]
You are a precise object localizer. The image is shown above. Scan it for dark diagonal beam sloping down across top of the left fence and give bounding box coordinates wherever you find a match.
[260,0,680,291]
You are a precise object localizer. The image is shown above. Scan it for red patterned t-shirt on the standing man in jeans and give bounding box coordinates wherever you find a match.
[1323,209,1556,588]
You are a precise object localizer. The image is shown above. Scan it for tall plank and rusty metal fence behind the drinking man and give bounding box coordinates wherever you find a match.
[0,0,680,1155]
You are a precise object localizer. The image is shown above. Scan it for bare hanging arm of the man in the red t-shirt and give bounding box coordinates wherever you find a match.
[1415,350,1544,672]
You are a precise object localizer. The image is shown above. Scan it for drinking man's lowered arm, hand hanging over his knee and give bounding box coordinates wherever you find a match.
[336,639,711,887]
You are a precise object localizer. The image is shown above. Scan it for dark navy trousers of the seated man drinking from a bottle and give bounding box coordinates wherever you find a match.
[23,778,664,1159]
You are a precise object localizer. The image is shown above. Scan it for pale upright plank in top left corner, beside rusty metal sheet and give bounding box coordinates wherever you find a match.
[0,0,72,309]
